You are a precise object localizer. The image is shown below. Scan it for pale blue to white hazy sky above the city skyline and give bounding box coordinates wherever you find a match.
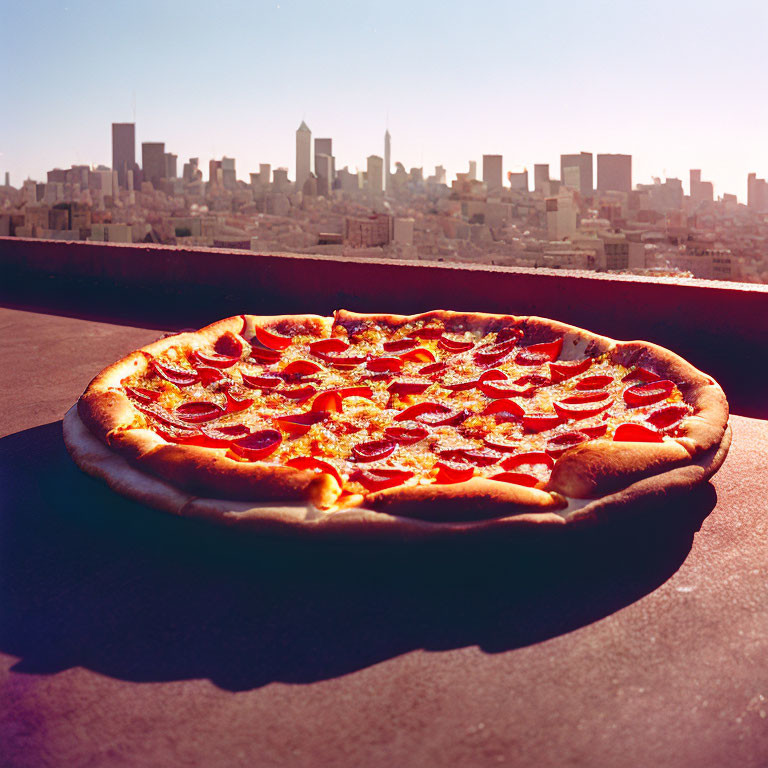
[0,0,768,199]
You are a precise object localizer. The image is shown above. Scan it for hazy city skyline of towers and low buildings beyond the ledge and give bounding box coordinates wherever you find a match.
[0,121,768,283]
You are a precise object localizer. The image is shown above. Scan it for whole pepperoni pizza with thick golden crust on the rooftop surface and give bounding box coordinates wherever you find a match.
[64,310,730,532]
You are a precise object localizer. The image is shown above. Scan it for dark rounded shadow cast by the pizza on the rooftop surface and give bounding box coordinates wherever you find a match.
[0,422,716,691]
